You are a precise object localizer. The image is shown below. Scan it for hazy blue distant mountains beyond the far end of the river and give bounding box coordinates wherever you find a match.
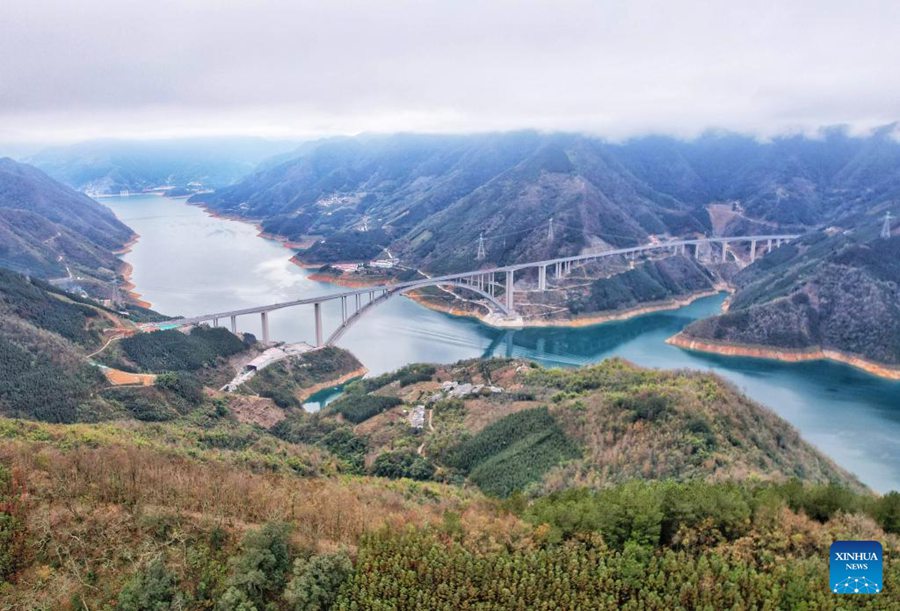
[26,138,296,195]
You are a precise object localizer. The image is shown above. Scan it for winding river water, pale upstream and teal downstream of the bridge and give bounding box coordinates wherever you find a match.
[101,195,900,492]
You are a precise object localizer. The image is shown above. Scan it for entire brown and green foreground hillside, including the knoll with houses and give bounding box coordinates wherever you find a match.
[0,361,900,611]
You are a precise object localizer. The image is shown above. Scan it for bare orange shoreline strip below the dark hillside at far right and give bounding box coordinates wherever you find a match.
[666,333,900,381]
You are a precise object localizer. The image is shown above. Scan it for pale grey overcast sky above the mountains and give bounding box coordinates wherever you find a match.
[0,0,900,142]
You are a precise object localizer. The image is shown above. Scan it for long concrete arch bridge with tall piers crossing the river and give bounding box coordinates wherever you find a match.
[160,234,798,346]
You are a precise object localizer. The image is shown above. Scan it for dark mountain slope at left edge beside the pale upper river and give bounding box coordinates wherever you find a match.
[0,158,132,281]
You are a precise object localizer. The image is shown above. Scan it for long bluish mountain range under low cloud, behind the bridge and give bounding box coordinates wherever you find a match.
[194,126,900,272]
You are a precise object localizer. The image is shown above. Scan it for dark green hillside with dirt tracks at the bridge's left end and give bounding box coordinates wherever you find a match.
[0,268,253,422]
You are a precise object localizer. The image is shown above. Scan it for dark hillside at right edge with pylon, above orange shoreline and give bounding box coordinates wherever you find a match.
[674,210,900,368]
